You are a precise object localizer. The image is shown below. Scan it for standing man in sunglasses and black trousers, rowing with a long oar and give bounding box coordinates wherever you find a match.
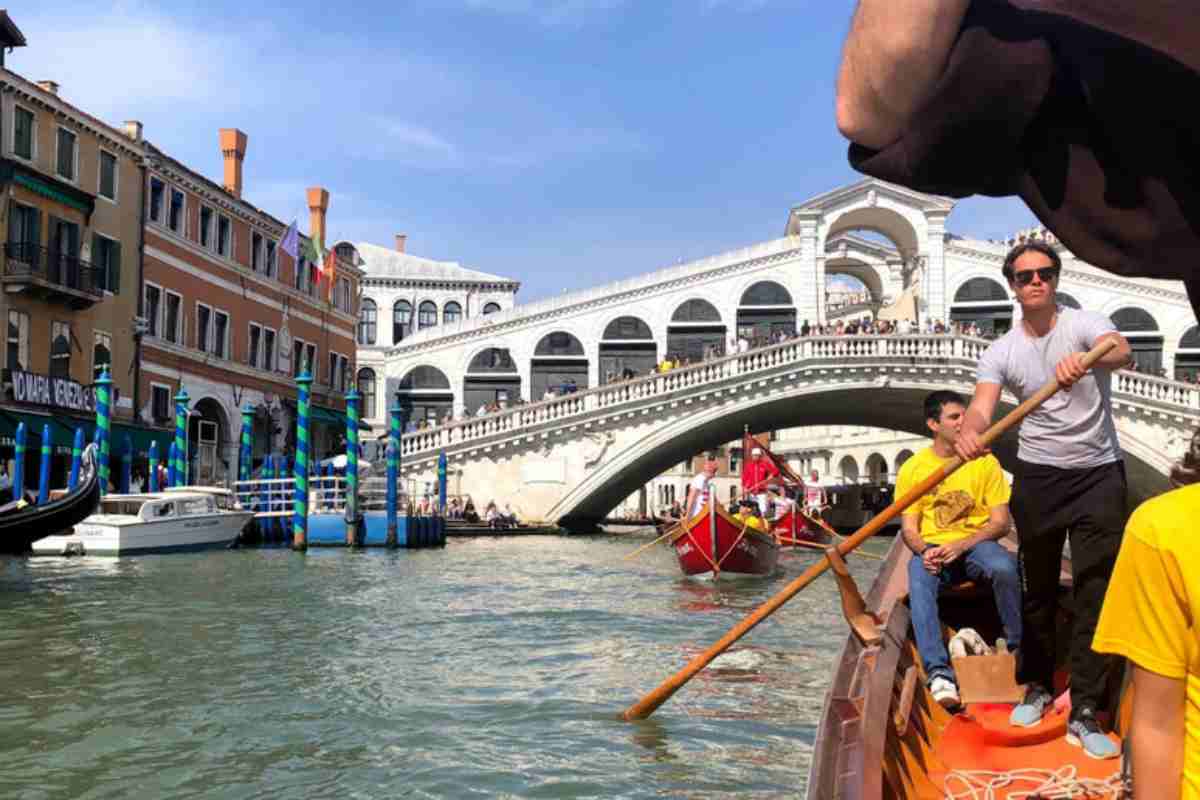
[955,241,1130,758]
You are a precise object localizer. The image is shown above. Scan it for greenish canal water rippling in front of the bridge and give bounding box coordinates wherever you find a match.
[0,534,887,799]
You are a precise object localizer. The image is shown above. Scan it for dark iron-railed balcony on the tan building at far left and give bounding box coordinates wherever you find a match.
[0,242,104,309]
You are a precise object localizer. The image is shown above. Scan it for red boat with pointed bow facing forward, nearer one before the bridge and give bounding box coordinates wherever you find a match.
[671,497,779,578]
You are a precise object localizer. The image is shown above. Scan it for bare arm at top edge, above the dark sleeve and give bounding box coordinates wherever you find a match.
[838,0,971,149]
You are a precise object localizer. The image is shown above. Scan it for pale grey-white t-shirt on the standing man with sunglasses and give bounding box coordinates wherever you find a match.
[976,306,1121,469]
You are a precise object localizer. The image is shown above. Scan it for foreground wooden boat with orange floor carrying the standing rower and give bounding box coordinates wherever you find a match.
[806,537,1132,800]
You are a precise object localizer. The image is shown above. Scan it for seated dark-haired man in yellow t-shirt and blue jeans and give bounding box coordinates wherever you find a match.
[896,391,1021,708]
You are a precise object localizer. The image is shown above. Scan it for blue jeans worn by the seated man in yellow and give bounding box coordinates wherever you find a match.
[908,542,1021,680]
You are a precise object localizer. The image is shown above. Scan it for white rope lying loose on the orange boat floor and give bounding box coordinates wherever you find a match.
[942,764,1132,800]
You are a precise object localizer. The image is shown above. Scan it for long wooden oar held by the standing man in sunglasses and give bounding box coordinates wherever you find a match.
[620,338,1116,720]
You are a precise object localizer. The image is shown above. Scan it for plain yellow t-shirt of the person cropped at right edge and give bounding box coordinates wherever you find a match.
[1092,485,1200,800]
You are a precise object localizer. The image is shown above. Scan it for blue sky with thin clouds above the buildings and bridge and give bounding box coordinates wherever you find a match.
[14,0,1034,302]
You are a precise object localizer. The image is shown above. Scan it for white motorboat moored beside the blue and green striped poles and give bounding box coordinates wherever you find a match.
[32,487,254,555]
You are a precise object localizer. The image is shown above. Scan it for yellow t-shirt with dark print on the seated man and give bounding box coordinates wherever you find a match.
[895,447,1013,545]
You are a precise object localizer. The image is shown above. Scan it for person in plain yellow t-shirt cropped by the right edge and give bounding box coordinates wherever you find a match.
[1092,431,1200,800]
